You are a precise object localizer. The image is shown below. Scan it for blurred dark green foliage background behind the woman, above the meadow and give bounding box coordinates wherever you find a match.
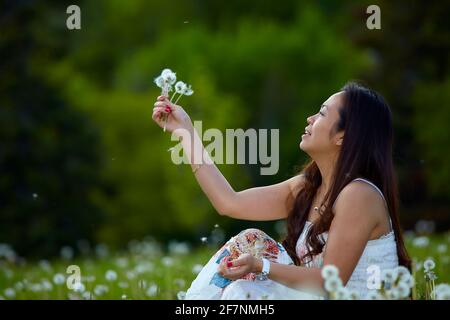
[0,0,450,258]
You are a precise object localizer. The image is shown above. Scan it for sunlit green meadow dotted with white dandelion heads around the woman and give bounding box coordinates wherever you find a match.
[0,233,450,300]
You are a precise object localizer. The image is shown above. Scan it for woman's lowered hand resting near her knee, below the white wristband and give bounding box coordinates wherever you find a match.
[218,253,262,280]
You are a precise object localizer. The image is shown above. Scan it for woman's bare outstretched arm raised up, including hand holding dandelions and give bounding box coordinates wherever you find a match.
[153,100,303,221]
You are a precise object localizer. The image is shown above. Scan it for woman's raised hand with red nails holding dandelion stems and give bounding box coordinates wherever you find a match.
[152,96,192,132]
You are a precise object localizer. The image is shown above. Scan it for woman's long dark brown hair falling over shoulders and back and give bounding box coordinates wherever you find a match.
[283,82,411,269]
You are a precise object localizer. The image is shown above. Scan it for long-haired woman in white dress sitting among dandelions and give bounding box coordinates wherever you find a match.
[153,83,410,299]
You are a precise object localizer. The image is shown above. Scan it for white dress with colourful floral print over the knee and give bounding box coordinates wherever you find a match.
[186,178,398,300]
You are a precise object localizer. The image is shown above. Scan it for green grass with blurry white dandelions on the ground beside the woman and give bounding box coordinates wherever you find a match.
[0,234,450,299]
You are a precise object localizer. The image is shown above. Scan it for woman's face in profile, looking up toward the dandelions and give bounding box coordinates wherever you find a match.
[300,92,344,157]
